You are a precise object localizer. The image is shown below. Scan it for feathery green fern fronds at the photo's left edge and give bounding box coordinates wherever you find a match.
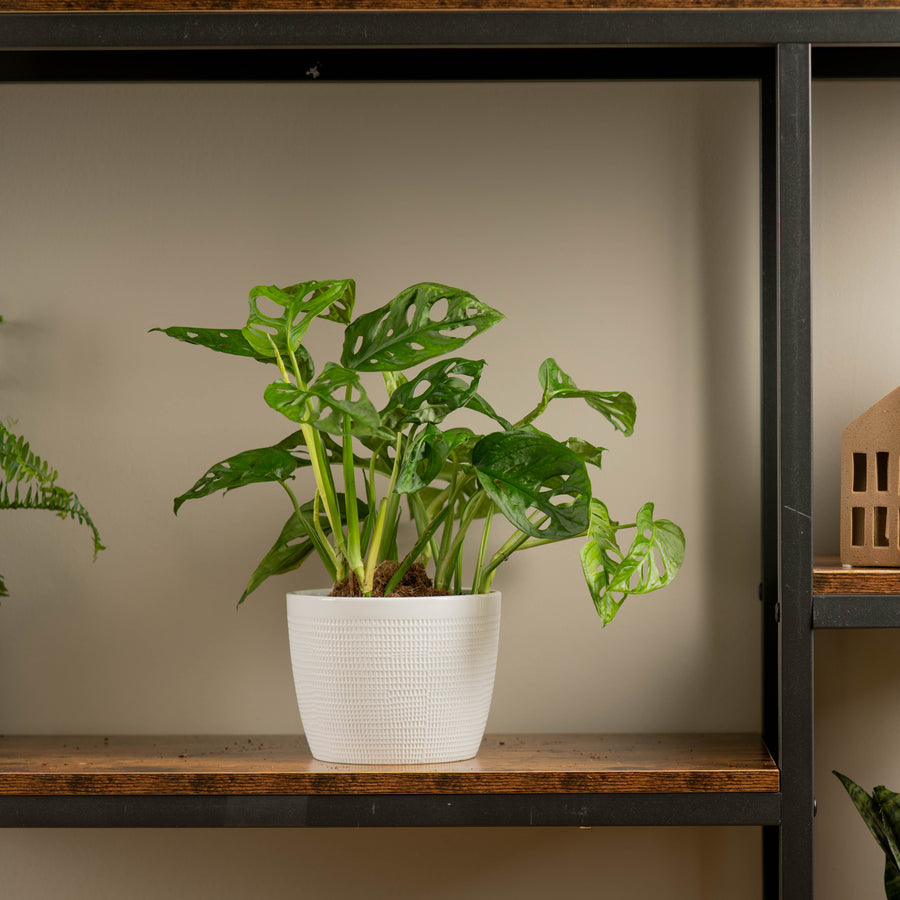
[0,316,105,597]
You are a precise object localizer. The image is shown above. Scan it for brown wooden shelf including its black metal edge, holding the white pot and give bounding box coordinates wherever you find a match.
[0,734,780,826]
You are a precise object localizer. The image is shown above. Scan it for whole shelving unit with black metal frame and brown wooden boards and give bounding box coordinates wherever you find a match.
[0,0,900,900]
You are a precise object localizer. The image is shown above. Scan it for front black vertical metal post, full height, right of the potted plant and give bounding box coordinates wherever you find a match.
[775,44,814,900]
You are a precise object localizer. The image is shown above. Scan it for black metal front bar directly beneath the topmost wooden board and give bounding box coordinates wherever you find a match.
[0,9,900,48]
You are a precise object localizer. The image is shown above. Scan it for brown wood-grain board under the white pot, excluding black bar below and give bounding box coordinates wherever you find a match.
[0,734,779,795]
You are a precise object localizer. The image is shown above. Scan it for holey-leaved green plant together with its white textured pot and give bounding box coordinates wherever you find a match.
[154,279,684,763]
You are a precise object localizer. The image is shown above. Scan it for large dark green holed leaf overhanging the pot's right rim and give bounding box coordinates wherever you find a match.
[472,428,591,540]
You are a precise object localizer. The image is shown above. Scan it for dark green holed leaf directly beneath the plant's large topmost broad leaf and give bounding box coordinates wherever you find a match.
[381,357,484,428]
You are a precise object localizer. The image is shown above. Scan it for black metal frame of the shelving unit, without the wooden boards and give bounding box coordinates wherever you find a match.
[0,10,900,900]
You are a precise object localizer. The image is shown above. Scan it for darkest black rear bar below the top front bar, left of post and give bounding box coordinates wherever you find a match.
[0,46,774,82]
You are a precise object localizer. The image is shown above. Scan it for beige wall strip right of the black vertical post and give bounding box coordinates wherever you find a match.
[813,83,900,900]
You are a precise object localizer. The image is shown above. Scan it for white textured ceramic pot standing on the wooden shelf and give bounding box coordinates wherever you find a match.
[287,591,500,765]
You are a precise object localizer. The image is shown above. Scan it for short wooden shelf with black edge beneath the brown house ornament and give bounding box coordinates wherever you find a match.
[813,557,900,628]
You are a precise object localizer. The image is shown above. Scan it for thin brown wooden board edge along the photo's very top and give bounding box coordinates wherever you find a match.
[0,0,900,13]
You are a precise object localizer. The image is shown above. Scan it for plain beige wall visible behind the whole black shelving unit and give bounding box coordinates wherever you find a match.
[0,74,884,900]
